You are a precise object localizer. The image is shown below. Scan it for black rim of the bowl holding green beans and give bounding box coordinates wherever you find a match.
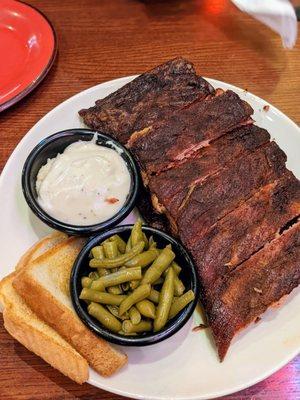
[70,224,199,346]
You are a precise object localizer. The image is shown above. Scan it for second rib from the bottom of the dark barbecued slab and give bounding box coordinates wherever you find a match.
[190,171,300,290]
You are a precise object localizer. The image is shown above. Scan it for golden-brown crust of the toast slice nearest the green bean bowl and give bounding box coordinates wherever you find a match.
[13,238,127,376]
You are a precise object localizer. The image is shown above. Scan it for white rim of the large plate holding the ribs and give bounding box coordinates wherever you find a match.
[0,75,300,400]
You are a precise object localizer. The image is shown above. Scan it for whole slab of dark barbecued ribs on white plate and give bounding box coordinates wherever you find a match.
[79,58,300,360]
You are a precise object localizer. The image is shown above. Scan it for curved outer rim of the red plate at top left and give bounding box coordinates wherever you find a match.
[0,0,58,112]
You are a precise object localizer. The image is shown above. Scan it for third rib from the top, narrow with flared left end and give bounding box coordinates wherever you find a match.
[147,125,270,218]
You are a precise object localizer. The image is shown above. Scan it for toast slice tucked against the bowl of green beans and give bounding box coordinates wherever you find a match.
[13,238,127,376]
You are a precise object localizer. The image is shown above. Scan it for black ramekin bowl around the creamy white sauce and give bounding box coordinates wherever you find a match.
[22,128,139,236]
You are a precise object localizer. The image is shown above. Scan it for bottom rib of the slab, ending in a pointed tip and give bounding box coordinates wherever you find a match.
[206,222,300,360]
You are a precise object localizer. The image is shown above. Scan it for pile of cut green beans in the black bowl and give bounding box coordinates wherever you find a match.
[79,220,195,337]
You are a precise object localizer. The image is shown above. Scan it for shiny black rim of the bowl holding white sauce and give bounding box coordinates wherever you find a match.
[22,128,140,236]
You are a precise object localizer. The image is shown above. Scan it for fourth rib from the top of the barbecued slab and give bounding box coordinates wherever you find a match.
[177,142,286,247]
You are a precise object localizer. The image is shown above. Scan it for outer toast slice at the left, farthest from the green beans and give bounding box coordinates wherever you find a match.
[0,272,89,384]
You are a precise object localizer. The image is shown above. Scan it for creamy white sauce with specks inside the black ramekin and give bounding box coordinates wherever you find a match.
[36,140,131,225]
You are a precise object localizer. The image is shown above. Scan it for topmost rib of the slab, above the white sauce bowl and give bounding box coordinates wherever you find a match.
[79,58,213,143]
